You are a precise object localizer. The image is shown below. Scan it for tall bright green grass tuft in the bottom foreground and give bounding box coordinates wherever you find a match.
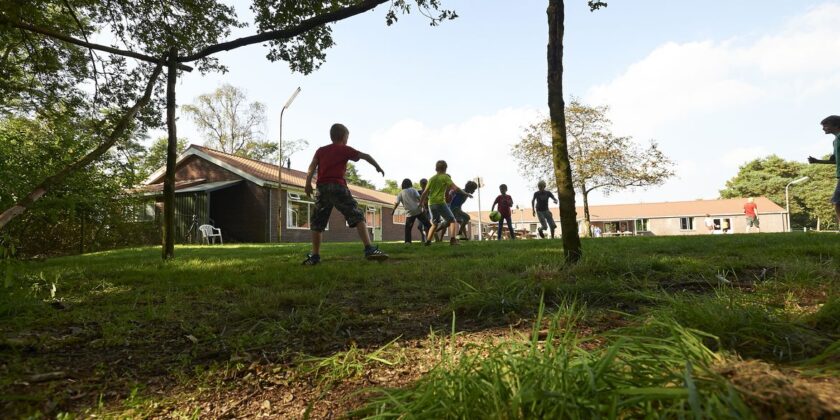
[355,303,750,419]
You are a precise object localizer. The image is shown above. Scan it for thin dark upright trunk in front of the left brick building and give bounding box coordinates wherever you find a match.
[163,47,178,260]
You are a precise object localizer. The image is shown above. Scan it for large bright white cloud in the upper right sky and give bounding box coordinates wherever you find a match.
[585,4,840,137]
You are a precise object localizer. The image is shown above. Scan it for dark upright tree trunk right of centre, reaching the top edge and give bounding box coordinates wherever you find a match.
[547,0,582,263]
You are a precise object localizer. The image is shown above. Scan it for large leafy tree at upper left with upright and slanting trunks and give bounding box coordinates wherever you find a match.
[0,0,456,259]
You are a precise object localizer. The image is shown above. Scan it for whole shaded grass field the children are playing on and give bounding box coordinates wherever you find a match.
[0,234,840,419]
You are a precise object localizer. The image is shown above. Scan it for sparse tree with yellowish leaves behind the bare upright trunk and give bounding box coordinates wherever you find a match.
[513,99,674,235]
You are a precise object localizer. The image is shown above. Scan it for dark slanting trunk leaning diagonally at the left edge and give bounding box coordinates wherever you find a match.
[0,66,162,229]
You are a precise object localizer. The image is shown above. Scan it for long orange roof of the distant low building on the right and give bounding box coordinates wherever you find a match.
[470,197,785,223]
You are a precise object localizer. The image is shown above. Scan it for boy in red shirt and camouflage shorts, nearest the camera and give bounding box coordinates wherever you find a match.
[303,124,388,265]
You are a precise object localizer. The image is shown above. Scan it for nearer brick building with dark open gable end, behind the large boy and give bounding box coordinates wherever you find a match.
[138,145,405,243]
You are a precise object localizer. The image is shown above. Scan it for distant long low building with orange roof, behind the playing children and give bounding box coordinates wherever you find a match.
[472,197,787,237]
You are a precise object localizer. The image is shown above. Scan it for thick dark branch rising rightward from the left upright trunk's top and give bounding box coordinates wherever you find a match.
[178,0,388,63]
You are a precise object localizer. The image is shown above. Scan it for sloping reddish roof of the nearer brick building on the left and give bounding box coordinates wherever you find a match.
[146,144,396,204]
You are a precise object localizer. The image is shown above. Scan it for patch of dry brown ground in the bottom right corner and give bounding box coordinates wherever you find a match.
[718,360,840,419]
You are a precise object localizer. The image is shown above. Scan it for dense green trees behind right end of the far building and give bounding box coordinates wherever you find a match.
[720,155,837,228]
